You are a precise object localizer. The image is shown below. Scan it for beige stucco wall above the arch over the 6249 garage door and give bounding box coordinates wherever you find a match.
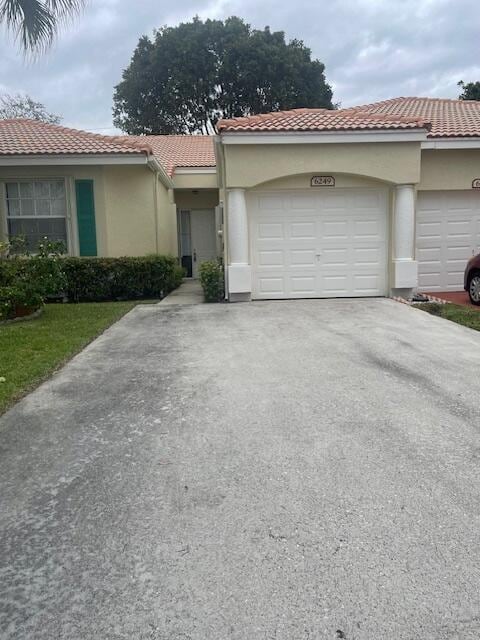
[223,142,420,188]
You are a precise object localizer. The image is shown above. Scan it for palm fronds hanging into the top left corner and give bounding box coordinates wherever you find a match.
[0,0,85,53]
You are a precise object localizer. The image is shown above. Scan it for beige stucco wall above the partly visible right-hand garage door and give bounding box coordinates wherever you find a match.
[418,149,480,191]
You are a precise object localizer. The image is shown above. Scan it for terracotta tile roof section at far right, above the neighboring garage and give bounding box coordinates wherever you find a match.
[348,98,480,138]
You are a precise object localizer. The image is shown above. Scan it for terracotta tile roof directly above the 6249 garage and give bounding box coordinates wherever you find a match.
[217,109,429,132]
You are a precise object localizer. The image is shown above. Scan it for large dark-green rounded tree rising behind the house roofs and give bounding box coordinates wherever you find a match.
[113,17,333,134]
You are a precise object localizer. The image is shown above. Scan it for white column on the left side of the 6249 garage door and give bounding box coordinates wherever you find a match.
[227,189,252,301]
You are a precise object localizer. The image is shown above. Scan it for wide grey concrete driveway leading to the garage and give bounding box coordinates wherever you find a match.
[0,300,480,640]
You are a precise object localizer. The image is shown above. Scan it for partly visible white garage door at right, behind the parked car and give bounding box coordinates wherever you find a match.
[417,191,480,291]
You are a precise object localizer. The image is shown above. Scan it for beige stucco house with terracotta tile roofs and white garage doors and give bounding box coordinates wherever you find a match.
[0,98,480,301]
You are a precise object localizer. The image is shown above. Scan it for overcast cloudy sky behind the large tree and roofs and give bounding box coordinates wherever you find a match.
[0,0,480,133]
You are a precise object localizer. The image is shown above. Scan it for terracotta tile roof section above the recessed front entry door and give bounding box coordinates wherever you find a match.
[127,135,216,177]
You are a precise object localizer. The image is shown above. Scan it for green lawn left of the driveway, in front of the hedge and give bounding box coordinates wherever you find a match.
[0,302,137,413]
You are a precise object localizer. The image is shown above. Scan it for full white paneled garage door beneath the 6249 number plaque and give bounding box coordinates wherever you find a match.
[248,187,387,299]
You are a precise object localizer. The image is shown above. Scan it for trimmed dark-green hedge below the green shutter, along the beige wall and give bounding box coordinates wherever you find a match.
[60,255,184,302]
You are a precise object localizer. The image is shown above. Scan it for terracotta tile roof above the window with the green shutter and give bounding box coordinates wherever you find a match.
[0,118,151,156]
